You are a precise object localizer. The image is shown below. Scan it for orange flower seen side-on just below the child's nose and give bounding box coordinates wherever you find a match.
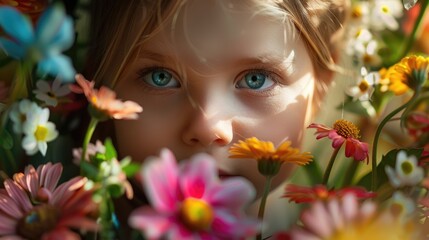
[229,137,313,176]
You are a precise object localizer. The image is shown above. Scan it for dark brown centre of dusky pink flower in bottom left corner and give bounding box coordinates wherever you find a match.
[16,205,60,240]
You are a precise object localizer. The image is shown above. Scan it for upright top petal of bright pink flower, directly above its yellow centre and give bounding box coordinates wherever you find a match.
[180,153,217,198]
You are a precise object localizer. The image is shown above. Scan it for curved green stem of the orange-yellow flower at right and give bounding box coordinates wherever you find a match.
[371,92,418,191]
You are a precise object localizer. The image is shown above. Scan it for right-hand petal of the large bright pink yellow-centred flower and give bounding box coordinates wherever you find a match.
[207,177,255,211]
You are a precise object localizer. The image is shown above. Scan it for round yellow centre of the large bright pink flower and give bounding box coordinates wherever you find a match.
[180,198,214,231]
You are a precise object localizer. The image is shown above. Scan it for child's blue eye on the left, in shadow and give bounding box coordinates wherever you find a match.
[141,69,180,88]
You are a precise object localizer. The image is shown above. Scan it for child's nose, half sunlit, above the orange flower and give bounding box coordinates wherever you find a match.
[182,112,233,147]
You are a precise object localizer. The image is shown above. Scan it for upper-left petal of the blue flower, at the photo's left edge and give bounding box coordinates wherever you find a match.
[0,6,34,45]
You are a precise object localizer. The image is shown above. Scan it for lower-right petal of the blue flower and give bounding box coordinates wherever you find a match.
[37,55,76,82]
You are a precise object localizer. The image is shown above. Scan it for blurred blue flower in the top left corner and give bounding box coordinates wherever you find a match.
[0,4,75,81]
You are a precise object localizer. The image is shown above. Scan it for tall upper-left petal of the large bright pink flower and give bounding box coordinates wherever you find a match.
[141,149,178,212]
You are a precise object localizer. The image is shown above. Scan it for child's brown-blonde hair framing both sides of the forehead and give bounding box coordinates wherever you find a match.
[86,0,349,99]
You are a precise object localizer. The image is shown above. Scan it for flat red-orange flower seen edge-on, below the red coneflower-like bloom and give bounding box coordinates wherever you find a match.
[283,184,376,203]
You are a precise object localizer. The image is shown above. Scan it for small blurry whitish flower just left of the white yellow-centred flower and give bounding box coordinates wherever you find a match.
[9,99,41,134]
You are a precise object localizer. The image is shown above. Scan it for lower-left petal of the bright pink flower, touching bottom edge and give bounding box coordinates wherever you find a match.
[128,207,172,239]
